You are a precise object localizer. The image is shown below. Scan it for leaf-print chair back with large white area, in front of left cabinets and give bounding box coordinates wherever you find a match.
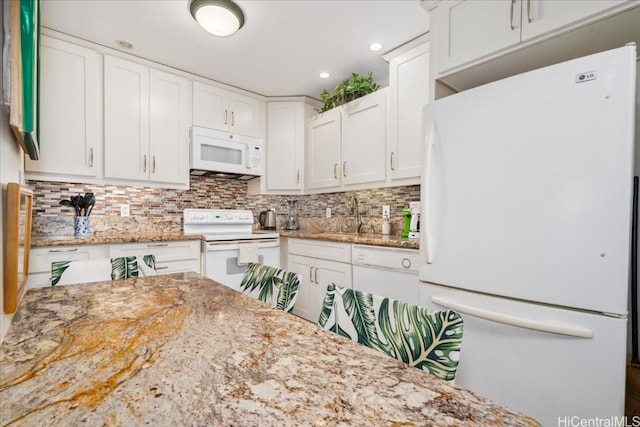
[51,255,156,286]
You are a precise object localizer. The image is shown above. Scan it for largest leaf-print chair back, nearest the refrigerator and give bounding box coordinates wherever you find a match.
[318,283,462,382]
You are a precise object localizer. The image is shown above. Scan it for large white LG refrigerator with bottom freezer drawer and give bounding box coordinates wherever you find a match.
[419,45,636,425]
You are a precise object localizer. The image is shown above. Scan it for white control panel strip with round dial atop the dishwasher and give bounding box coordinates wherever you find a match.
[352,245,420,274]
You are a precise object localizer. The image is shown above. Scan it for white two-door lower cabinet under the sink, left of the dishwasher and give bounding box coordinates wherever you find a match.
[287,239,351,323]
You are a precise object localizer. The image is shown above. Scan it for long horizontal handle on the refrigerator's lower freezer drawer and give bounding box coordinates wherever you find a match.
[431,295,594,338]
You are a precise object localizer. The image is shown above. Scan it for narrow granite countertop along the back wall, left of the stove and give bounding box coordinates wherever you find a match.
[31,232,202,248]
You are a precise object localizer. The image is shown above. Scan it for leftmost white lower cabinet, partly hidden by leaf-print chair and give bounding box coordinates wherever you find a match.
[27,245,109,288]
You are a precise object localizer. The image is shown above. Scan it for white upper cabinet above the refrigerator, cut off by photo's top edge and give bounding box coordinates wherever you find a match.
[435,0,630,74]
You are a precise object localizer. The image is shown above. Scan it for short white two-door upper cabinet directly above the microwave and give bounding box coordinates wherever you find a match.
[193,82,262,138]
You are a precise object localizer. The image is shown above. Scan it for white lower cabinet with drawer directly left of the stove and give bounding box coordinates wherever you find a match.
[109,240,201,274]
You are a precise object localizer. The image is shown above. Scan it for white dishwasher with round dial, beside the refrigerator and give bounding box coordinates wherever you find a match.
[351,244,420,304]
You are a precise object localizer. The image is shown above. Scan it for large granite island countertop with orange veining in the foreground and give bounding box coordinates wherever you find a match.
[0,273,539,426]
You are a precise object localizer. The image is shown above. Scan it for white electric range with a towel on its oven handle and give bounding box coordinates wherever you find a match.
[184,209,280,291]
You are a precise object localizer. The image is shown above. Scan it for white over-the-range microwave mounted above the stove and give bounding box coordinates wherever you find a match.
[190,126,264,179]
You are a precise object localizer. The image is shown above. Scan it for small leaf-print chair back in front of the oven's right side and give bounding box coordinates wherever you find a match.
[240,262,301,313]
